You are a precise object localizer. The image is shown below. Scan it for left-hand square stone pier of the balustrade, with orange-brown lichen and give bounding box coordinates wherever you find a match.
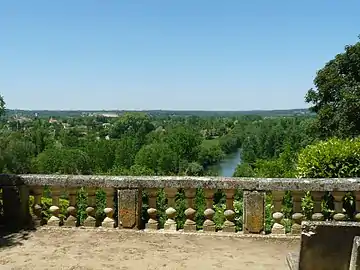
[118,189,141,229]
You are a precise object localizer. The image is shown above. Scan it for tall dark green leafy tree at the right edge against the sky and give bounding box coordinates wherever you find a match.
[305,39,360,138]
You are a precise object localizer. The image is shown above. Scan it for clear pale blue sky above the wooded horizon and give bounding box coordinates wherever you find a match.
[0,0,360,110]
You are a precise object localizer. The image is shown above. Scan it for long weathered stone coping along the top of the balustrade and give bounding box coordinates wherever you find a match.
[16,174,360,191]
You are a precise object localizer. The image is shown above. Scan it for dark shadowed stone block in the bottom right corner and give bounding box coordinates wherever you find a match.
[298,221,360,270]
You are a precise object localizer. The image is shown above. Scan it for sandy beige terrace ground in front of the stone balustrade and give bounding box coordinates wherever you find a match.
[0,228,299,270]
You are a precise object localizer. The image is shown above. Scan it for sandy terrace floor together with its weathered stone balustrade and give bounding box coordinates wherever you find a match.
[0,175,360,269]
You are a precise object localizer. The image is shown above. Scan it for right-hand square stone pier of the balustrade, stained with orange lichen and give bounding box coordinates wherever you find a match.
[243,191,265,233]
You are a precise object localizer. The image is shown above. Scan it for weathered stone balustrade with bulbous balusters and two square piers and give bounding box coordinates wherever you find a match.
[0,175,360,234]
